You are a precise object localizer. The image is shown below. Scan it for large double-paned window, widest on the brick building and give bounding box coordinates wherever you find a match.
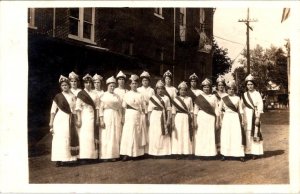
[69,8,96,44]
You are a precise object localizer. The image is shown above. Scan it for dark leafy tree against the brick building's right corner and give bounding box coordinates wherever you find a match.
[212,40,232,79]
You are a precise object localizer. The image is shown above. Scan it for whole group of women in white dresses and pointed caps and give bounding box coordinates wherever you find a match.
[49,70,263,166]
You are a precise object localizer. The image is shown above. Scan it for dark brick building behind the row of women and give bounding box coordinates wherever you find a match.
[28,8,214,144]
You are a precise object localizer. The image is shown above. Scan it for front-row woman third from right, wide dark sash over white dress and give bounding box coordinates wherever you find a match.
[194,78,219,159]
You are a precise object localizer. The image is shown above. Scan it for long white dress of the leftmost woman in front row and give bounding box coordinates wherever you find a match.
[51,92,76,161]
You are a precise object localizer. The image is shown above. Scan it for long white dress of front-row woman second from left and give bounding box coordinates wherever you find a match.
[76,89,100,159]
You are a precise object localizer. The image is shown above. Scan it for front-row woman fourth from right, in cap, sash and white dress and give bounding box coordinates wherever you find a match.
[172,82,194,159]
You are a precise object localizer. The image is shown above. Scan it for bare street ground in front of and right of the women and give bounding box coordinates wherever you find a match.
[29,110,289,184]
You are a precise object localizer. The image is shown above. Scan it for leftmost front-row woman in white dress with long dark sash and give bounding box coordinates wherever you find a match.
[49,76,79,167]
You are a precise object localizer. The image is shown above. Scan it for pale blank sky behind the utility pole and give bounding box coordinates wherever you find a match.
[214,7,291,77]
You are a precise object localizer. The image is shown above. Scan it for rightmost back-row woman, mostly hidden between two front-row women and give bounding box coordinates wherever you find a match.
[214,75,227,152]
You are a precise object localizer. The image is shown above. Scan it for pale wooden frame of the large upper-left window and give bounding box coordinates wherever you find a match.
[68,7,96,45]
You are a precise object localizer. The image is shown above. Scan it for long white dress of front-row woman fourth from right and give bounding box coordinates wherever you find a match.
[171,96,193,154]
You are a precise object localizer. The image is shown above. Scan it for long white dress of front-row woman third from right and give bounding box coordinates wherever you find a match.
[194,93,219,156]
